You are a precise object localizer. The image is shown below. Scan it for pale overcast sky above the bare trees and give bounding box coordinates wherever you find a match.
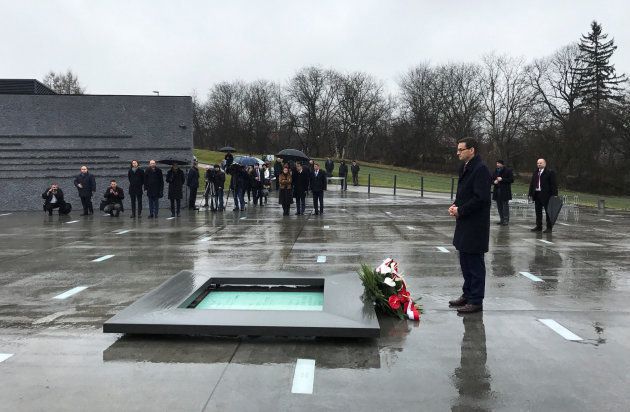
[0,0,630,96]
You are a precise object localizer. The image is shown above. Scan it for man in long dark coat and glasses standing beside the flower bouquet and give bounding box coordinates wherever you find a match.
[448,137,492,313]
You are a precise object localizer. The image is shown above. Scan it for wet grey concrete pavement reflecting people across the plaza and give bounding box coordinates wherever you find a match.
[0,191,630,411]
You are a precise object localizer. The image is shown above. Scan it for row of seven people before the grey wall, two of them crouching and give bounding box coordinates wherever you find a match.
[42,160,205,219]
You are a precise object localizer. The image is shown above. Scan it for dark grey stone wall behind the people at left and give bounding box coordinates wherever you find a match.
[0,95,193,211]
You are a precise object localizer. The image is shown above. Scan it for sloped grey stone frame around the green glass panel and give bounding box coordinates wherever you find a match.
[103,271,380,338]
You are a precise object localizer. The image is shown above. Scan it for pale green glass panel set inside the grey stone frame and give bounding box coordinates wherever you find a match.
[196,291,324,310]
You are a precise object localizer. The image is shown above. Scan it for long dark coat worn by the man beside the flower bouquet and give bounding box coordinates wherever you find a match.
[453,155,492,253]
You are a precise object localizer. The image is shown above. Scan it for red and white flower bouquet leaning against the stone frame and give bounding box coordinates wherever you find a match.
[359,258,422,320]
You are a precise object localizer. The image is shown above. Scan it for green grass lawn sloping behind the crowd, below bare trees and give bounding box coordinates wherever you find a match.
[194,149,630,210]
